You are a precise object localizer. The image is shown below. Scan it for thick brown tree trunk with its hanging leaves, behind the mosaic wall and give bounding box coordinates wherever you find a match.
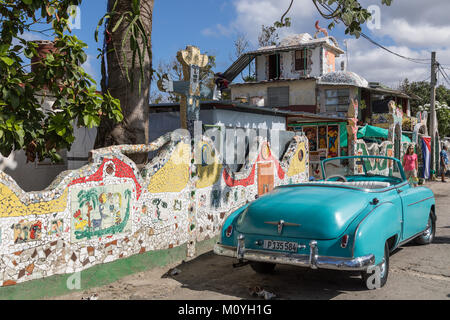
[95,0,154,163]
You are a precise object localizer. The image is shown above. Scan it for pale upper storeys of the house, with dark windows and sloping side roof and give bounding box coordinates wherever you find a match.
[227,33,344,113]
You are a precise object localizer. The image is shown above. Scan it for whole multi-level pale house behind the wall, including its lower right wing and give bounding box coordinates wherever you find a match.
[222,33,417,161]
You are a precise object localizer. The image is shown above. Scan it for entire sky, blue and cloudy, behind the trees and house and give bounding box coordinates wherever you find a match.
[22,0,450,88]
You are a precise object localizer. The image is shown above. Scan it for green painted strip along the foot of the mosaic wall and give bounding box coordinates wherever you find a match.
[0,237,217,300]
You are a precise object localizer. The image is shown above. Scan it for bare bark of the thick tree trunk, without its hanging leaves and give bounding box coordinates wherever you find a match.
[95,0,154,163]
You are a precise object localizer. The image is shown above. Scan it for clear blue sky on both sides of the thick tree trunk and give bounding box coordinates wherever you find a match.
[61,0,248,82]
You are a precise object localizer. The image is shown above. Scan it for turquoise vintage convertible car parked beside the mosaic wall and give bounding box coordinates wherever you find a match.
[214,156,436,289]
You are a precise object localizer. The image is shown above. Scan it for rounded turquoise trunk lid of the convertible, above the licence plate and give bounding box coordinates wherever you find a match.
[236,186,374,240]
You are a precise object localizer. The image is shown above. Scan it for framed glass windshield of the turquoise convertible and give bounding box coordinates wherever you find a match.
[322,156,404,184]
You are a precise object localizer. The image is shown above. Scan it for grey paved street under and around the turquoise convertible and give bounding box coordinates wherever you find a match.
[54,181,450,300]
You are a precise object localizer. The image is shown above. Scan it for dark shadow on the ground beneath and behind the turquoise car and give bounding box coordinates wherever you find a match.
[163,252,367,300]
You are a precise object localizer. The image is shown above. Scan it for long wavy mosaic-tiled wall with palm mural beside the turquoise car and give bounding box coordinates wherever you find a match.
[0,134,309,286]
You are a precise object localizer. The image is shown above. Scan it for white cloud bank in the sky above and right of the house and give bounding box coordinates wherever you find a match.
[203,0,450,88]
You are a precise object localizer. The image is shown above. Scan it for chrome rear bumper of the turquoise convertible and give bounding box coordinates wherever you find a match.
[214,238,375,271]
